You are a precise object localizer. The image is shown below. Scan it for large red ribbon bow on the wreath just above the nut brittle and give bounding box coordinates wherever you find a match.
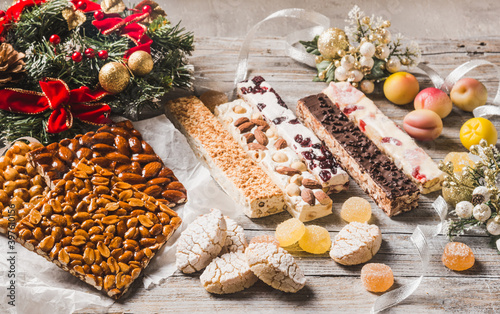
[0,79,112,133]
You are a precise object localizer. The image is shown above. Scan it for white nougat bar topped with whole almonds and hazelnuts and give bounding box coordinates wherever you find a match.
[215,99,332,221]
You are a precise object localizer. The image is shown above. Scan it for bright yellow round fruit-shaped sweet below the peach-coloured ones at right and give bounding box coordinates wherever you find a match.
[460,118,498,149]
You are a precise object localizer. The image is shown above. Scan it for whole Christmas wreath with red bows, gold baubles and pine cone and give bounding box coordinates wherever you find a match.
[0,0,193,143]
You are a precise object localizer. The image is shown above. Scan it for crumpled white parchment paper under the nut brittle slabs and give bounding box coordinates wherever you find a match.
[0,115,238,314]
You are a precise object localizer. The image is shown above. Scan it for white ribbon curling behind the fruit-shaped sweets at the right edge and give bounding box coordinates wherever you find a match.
[418,60,500,118]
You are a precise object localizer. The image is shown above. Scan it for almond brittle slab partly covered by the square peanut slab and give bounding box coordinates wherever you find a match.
[28,121,187,207]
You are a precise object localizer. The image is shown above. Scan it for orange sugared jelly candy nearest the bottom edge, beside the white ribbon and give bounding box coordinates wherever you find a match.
[361,263,394,292]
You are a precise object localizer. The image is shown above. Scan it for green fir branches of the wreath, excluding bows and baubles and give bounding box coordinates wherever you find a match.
[0,0,194,144]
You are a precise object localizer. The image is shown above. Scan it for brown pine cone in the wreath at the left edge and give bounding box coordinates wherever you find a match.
[0,43,25,86]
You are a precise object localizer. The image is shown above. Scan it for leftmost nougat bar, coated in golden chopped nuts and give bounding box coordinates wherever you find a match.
[167,96,287,218]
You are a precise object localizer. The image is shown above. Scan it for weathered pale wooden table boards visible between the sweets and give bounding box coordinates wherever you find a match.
[84,37,500,313]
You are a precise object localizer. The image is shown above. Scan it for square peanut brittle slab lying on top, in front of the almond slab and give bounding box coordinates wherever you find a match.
[14,159,181,299]
